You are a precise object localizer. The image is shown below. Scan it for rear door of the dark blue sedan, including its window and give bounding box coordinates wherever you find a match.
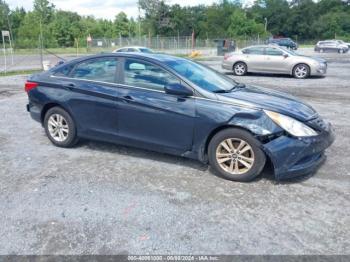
[61,57,119,140]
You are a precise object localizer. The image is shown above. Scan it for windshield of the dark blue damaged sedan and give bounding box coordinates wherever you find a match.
[166,59,238,93]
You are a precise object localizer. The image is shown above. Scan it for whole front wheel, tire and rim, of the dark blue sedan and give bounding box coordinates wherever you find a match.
[208,128,266,182]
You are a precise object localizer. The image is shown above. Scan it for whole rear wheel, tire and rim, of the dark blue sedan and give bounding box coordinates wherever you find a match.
[44,107,78,147]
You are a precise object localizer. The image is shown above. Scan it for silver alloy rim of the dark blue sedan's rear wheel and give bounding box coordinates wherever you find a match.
[47,114,69,142]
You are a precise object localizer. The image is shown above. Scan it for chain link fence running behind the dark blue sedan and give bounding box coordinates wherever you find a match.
[0,36,265,74]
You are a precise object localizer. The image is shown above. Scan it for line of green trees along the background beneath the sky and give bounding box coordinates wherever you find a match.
[0,0,350,48]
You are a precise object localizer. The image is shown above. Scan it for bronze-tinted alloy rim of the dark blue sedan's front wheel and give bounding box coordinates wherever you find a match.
[216,138,255,175]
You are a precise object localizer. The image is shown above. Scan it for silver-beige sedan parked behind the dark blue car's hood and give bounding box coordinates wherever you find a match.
[222,45,327,79]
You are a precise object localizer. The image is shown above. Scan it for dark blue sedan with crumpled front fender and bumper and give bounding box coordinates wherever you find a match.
[25,53,334,181]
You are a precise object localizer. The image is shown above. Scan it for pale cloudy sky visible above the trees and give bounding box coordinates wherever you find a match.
[5,0,253,19]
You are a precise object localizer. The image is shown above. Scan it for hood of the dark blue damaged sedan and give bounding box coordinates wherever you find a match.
[217,86,317,122]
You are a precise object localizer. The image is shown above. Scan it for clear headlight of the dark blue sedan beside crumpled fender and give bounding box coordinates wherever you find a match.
[264,110,318,137]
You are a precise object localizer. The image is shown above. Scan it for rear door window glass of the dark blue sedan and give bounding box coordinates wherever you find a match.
[70,57,117,83]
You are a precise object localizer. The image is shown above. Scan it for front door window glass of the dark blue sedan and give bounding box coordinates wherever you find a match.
[124,59,180,91]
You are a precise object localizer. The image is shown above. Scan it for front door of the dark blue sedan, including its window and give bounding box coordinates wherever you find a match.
[118,58,196,152]
